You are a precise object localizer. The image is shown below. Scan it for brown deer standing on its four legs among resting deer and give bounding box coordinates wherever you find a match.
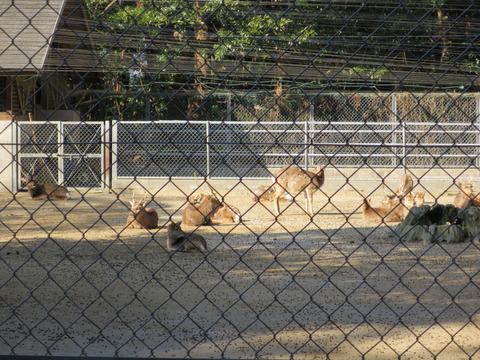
[272,166,325,216]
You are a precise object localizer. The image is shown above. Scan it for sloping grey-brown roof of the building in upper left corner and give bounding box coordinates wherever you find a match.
[0,0,81,71]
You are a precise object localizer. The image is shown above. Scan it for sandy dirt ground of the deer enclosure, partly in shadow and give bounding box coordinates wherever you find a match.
[0,185,480,359]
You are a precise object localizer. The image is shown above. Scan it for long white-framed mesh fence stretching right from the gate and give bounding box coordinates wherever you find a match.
[113,120,480,178]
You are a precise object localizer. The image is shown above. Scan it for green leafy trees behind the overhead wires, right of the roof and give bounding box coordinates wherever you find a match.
[85,0,480,120]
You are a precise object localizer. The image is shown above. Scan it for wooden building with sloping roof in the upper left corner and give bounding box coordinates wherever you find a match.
[0,0,96,120]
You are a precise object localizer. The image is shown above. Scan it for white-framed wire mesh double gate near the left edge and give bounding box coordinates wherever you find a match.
[17,121,105,188]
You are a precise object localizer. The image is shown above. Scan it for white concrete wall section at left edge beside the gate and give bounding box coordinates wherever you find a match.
[0,120,16,192]
